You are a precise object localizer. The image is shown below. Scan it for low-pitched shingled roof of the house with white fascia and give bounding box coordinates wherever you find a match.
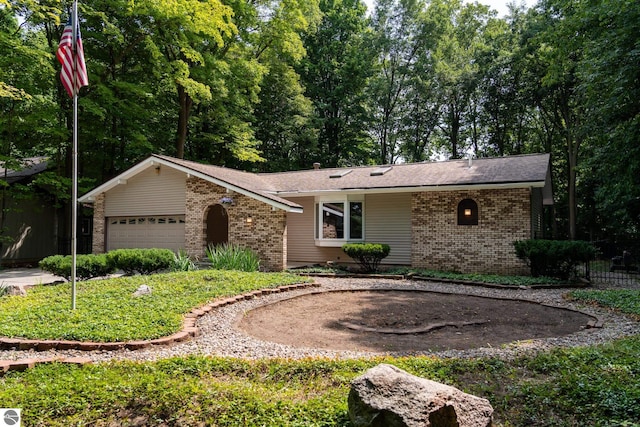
[80,154,553,212]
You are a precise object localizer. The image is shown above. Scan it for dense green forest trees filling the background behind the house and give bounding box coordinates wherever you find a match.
[0,0,640,247]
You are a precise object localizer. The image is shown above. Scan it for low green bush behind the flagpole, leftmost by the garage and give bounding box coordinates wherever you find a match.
[39,254,116,280]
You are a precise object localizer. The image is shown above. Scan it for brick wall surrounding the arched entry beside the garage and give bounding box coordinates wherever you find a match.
[185,177,287,271]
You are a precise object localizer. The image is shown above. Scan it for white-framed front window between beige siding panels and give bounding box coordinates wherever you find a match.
[315,199,364,246]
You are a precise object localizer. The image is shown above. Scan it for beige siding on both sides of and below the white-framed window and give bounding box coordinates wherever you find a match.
[287,193,411,265]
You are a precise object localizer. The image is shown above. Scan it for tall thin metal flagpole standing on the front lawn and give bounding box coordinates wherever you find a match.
[71,0,78,310]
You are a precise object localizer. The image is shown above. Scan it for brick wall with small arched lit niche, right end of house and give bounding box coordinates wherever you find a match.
[411,189,531,274]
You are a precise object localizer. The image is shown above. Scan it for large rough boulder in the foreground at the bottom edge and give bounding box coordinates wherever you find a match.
[349,364,493,427]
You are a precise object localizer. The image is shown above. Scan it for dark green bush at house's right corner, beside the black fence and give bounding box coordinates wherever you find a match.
[513,239,596,280]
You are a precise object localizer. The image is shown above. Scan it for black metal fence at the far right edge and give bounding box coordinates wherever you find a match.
[585,240,640,286]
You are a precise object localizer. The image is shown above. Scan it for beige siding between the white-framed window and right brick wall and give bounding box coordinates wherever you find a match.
[365,193,411,265]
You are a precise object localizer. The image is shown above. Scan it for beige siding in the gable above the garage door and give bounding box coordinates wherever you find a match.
[105,167,187,217]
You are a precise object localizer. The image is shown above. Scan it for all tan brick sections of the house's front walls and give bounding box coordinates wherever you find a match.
[92,177,531,274]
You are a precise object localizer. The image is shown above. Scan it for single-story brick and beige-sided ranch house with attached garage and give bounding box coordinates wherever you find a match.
[79,154,553,274]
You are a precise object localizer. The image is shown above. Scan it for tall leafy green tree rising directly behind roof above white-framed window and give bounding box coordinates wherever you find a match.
[297,0,375,166]
